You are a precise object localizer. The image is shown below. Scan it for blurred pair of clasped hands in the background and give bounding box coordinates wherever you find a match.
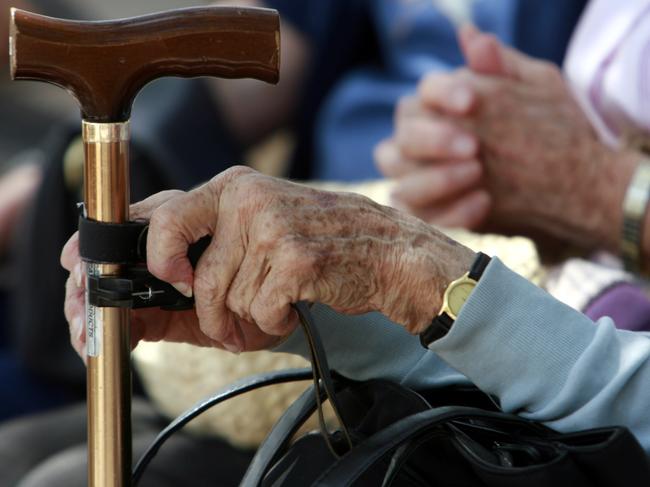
[375,29,642,251]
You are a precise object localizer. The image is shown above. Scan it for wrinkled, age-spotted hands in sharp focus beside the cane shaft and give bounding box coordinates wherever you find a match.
[62,167,474,353]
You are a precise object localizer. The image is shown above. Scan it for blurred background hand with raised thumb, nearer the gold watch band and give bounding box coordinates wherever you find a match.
[380,24,637,248]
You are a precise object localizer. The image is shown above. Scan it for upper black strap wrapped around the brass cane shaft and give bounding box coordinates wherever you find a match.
[79,216,148,264]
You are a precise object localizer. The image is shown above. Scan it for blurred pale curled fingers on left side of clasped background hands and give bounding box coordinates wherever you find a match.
[375,75,490,228]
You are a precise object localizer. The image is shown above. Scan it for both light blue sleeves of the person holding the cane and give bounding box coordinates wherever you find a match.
[280,258,650,453]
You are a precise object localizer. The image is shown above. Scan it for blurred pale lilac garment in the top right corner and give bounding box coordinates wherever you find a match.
[564,0,650,147]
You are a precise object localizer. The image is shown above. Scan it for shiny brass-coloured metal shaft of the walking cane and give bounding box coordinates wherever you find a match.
[82,122,131,487]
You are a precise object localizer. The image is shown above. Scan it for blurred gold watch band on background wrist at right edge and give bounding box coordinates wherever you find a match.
[621,159,650,273]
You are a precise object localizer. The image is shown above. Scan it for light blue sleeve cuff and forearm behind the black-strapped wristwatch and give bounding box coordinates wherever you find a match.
[433,261,650,451]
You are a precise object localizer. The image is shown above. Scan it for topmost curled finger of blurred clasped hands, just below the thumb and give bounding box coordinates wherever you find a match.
[418,71,478,117]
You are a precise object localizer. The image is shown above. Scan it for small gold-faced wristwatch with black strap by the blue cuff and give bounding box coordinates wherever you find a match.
[420,252,490,348]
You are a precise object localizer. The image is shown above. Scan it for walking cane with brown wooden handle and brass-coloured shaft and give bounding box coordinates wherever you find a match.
[10,7,280,487]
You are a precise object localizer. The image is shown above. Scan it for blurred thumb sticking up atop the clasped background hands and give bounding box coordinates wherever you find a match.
[458,24,548,82]
